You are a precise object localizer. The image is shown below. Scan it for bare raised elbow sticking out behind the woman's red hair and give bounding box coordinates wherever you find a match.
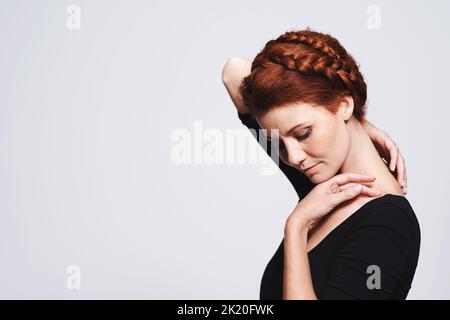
[222,57,252,113]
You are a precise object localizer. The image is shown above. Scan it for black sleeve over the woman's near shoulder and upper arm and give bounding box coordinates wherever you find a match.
[316,203,420,300]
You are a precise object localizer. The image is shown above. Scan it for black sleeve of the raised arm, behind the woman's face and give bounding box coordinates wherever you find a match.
[238,112,315,200]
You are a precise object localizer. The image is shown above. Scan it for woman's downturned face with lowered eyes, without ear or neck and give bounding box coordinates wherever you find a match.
[257,103,351,184]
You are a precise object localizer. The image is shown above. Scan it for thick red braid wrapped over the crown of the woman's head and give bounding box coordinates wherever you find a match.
[243,28,367,120]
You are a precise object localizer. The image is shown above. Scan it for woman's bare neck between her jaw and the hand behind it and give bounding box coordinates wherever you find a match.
[339,117,404,195]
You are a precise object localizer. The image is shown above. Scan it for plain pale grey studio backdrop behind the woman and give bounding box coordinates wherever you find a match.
[0,0,450,299]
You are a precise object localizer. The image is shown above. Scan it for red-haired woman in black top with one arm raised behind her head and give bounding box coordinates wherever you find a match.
[222,28,420,299]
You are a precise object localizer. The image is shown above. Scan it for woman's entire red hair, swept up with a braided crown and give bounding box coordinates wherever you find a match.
[239,28,367,120]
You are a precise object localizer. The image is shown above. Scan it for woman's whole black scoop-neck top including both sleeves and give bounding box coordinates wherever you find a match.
[238,113,420,300]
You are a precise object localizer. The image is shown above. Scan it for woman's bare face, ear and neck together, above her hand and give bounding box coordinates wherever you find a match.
[256,97,404,195]
